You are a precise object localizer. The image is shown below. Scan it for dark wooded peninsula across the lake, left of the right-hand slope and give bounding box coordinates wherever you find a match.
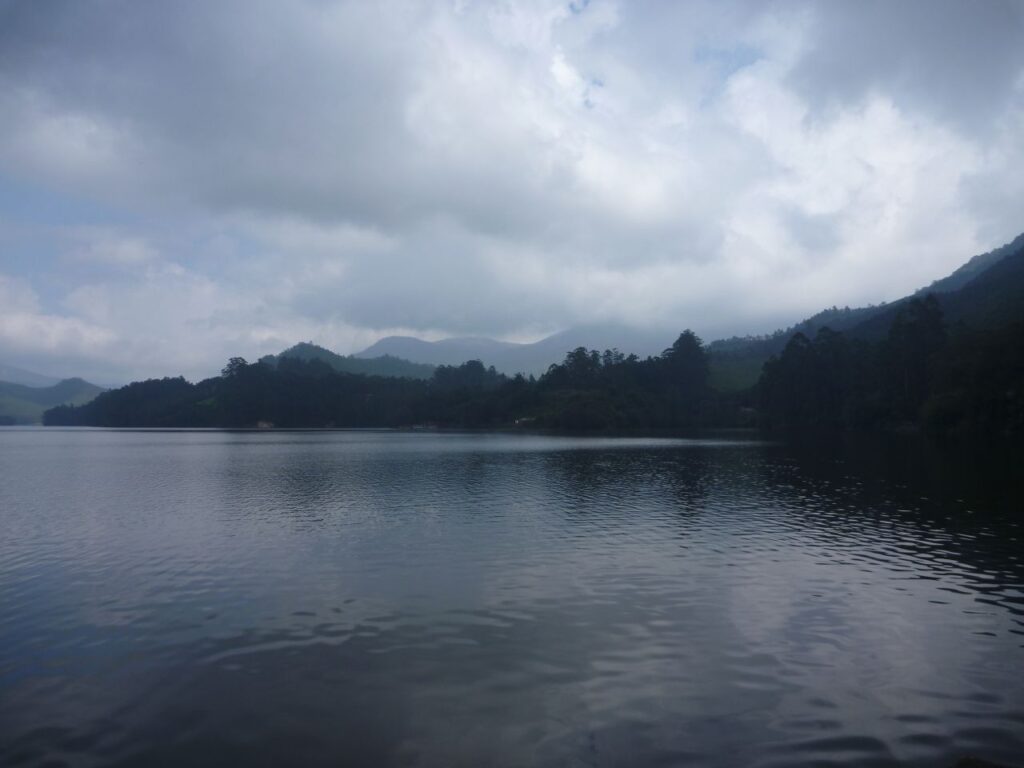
[44,331,728,431]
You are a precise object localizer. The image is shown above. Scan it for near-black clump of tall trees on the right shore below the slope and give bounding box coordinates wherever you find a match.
[757,295,1024,435]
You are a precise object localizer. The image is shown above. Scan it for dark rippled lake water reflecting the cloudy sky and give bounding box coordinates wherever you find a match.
[0,430,1024,766]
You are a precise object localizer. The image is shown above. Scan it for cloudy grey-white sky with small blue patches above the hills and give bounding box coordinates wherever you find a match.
[0,0,1024,382]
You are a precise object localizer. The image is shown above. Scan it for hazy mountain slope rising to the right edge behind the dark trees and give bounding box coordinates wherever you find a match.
[709,234,1024,390]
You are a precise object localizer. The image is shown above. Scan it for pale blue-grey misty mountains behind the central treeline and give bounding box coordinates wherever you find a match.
[354,325,676,376]
